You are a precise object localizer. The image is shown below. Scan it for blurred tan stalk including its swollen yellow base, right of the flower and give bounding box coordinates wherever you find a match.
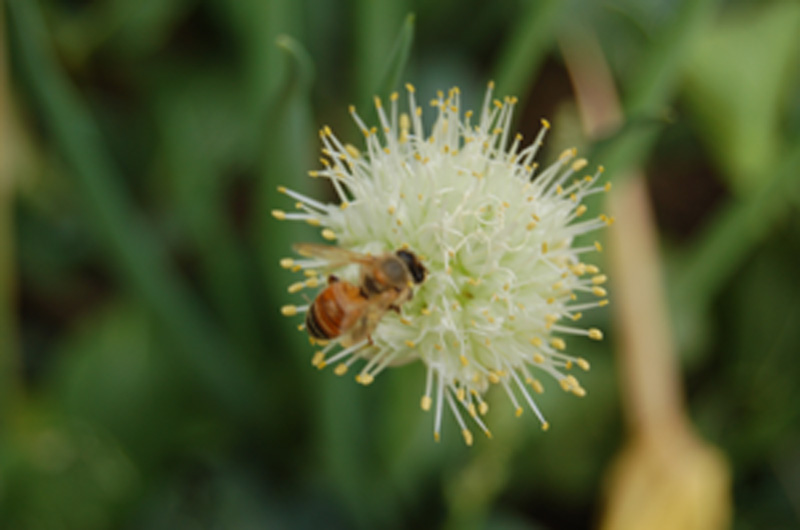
[562,27,730,530]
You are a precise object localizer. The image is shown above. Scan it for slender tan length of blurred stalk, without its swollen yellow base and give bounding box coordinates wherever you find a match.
[562,33,686,438]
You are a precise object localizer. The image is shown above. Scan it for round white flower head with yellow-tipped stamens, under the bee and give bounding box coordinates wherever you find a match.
[273,83,613,444]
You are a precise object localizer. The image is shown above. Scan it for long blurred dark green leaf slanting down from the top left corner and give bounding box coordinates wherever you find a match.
[7,0,258,415]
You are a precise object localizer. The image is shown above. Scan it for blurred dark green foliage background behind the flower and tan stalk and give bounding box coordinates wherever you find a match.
[0,0,800,530]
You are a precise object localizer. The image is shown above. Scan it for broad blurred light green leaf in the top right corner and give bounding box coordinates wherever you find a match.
[686,2,800,194]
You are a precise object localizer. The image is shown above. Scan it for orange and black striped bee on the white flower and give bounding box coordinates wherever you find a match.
[294,243,427,347]
